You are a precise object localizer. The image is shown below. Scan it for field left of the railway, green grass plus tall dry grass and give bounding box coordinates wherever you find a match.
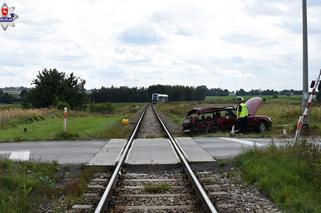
[0,104,141,142]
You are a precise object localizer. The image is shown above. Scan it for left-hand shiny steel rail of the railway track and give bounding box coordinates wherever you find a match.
[95,106,147,213]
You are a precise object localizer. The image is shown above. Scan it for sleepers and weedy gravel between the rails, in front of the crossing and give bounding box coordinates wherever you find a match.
[109,167,201,213]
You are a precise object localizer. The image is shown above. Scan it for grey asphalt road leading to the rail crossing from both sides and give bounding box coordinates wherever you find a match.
[0,137,321,164]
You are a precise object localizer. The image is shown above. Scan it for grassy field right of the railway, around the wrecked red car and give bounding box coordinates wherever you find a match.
[158,96,321,137]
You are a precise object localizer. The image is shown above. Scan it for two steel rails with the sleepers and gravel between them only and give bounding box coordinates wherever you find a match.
[90,105,216,213]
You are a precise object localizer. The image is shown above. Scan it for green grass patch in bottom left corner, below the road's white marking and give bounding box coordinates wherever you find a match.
[0,160,59,212]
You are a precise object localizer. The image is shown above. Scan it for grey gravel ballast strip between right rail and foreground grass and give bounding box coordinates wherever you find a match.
[194,167,281,213]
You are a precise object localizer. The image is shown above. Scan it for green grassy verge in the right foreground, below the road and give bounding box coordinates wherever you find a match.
[237,143,321,212]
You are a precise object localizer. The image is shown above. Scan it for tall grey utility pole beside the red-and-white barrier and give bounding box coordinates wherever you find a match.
[302,0,309,128]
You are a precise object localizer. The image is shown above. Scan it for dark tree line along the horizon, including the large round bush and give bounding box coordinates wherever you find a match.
[0,69,321,108]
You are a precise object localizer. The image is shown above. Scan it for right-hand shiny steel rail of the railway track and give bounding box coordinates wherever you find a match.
[152,106,217,213]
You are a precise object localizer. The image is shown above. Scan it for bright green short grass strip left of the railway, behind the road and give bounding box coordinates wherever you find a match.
[0,114,132,142]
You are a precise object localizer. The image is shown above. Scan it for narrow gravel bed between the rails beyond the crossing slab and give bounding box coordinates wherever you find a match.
[137,106,165,138]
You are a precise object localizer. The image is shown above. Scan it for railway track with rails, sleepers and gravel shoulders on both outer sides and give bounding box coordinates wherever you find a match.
[70,105,279,213]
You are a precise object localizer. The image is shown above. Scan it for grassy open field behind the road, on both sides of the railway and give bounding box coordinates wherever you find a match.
[0,96,321,142]
